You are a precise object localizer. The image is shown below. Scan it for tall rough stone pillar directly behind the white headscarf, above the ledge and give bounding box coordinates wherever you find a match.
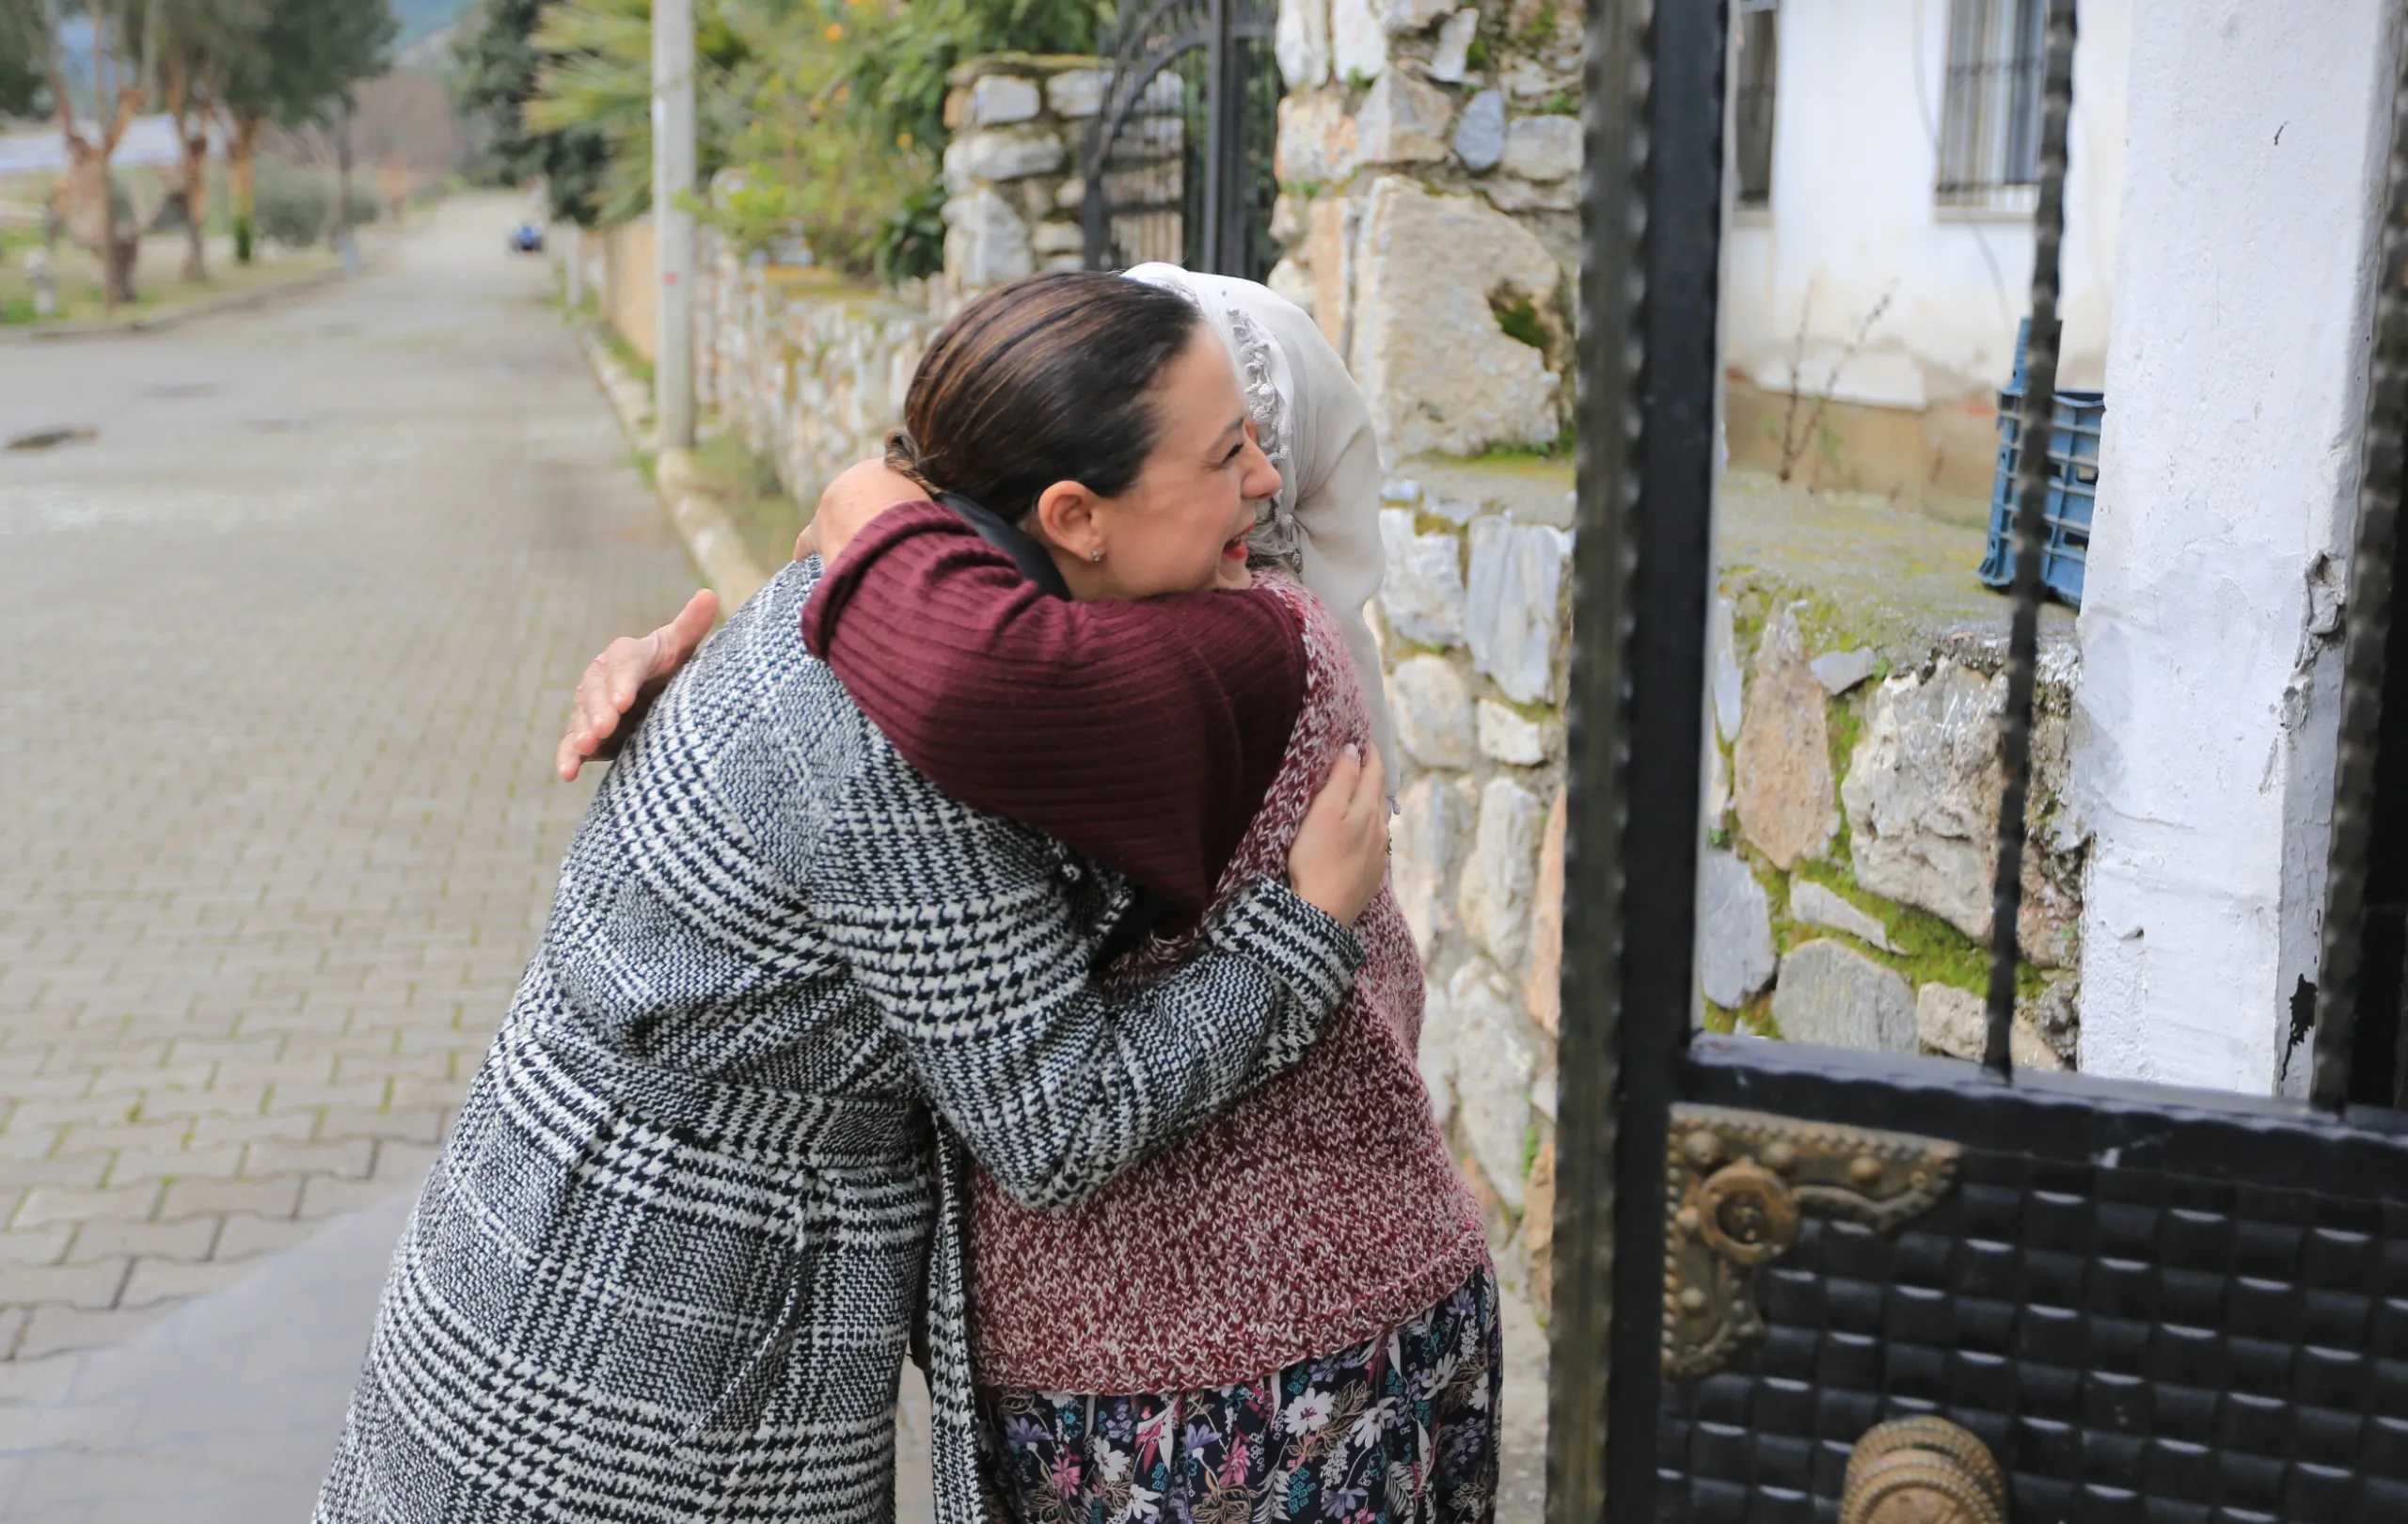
[1272,0,1582,460]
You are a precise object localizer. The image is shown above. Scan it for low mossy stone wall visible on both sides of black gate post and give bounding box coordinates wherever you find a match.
[1375,474,2083,1312]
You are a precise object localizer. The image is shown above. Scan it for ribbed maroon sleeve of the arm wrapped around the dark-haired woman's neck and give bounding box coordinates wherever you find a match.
[801,503,1306,922]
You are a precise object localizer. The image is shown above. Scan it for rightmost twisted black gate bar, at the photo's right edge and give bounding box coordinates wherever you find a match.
[2309,26,2408,1112]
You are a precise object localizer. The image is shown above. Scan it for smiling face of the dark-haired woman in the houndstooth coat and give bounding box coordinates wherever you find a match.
[1036,323,1278,599]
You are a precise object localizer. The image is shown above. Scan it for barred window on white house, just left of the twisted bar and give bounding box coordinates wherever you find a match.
[1939,0,2047,212]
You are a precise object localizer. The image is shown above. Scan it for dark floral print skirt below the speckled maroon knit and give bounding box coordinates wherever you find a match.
[977,1264,1505,1524]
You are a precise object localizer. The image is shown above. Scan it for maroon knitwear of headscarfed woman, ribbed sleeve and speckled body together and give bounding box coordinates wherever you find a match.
[804,508,1488,1391]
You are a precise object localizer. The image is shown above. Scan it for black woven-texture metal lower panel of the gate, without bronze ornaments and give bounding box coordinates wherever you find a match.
[1652,1038,2408,1524]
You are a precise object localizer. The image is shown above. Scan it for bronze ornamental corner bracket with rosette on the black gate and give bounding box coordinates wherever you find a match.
[1664,1105,1965,1379]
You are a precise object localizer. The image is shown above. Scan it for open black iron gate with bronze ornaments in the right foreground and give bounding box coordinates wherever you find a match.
[1548,0,2408,1524]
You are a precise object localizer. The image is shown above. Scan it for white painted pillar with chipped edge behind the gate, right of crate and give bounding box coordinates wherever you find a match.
[2073,0,2399,1093]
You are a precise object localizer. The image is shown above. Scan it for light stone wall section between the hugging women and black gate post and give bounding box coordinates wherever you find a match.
[1372,482,1573,1312]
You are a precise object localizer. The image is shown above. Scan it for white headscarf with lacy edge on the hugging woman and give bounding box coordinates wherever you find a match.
[1127,265,1402,789]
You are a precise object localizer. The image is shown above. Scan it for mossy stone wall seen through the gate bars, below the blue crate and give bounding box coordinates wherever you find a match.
[1698,576,2085,1069]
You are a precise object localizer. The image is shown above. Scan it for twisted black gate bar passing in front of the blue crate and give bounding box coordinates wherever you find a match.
[1982,0,2073,1079]
